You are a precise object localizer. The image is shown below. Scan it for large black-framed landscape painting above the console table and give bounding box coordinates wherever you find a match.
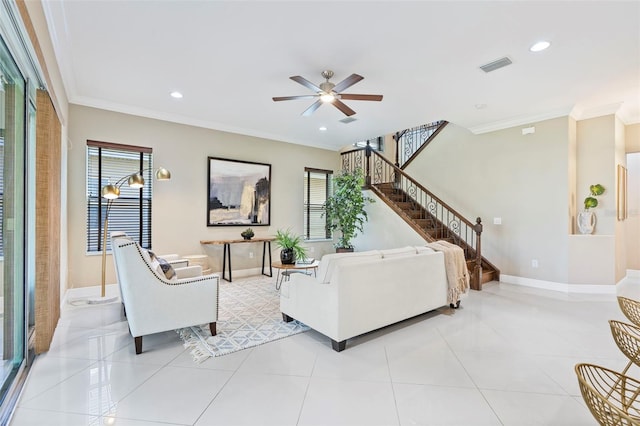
[207,157,271,226]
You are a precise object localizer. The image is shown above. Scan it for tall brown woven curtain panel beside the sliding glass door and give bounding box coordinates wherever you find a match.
[35,90,61,353]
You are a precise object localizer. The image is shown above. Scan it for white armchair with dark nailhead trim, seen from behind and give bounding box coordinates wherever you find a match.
[111,234,219,354]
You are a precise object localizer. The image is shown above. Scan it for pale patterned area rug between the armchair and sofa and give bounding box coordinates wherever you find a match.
[177,276,309,362]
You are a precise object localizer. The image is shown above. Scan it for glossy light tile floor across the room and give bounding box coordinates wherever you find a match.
[11,280,640,426]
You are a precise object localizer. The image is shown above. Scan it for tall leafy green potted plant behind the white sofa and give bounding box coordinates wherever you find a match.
[324,169,374,252]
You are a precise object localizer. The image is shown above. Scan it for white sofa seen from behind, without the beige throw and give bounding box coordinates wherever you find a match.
[280,247,459,352]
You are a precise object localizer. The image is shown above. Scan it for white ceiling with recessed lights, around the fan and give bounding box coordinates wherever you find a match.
[43,0,640,149]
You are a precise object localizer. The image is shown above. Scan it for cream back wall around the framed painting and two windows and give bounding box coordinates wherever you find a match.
[67,105,340,288]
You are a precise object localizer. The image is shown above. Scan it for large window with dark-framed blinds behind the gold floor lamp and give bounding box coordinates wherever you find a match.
[87,141,153,252]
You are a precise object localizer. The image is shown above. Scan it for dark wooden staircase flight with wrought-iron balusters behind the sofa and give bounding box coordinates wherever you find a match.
[342,147,500,290]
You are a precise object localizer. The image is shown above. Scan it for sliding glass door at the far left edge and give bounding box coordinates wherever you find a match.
[0,34,28,422]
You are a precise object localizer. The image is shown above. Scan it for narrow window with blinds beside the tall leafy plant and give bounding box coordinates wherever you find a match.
[304,167,333,240]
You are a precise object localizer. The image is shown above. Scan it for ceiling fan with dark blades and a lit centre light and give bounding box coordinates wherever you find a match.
[273,70,382,117]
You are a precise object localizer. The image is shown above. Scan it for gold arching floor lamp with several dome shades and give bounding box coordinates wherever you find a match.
[88,167,171,305]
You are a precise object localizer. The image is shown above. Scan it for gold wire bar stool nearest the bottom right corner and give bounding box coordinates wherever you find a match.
[575,364,640,426]
